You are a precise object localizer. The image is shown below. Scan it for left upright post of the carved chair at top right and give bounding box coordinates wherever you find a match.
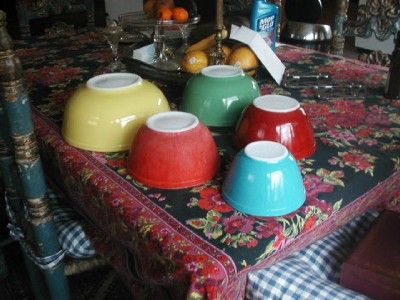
[331,0,349,55]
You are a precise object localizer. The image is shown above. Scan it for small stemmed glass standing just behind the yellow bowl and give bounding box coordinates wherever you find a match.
[103,20,126,72]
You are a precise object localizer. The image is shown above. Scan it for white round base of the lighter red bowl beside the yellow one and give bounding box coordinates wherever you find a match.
[146,111,200,133]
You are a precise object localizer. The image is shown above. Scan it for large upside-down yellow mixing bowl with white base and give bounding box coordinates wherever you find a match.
[62,73,170,152]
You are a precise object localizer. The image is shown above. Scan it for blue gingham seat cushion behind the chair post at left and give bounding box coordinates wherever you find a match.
[47,188,96,258]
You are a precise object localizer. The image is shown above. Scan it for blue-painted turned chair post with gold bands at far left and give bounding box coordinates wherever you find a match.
[0,11,70,300]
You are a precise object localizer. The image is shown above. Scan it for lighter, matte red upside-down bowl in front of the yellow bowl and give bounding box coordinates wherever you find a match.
[128,111,220,189]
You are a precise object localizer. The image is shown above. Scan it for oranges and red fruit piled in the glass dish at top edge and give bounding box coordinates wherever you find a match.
[143,0,189,23]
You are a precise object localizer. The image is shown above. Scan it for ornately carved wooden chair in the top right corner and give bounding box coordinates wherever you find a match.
[331,0,400,65]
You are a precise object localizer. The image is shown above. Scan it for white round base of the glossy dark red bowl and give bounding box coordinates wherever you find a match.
[253,94,300,113]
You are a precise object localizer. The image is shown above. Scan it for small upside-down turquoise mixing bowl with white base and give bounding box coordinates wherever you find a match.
[222,141,306,217]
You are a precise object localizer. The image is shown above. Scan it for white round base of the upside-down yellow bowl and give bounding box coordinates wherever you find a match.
[86,73,143,91]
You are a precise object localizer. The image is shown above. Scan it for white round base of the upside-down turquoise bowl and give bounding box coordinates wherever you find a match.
[244,141,289,163]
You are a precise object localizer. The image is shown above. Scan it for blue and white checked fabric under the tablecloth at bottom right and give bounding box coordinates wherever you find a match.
[246,212,378,300]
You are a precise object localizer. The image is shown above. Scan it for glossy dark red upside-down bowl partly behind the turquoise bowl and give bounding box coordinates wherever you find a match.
[234,95,316,160]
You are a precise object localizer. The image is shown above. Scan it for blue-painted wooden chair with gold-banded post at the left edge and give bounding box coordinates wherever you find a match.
[0,11,103,300]
